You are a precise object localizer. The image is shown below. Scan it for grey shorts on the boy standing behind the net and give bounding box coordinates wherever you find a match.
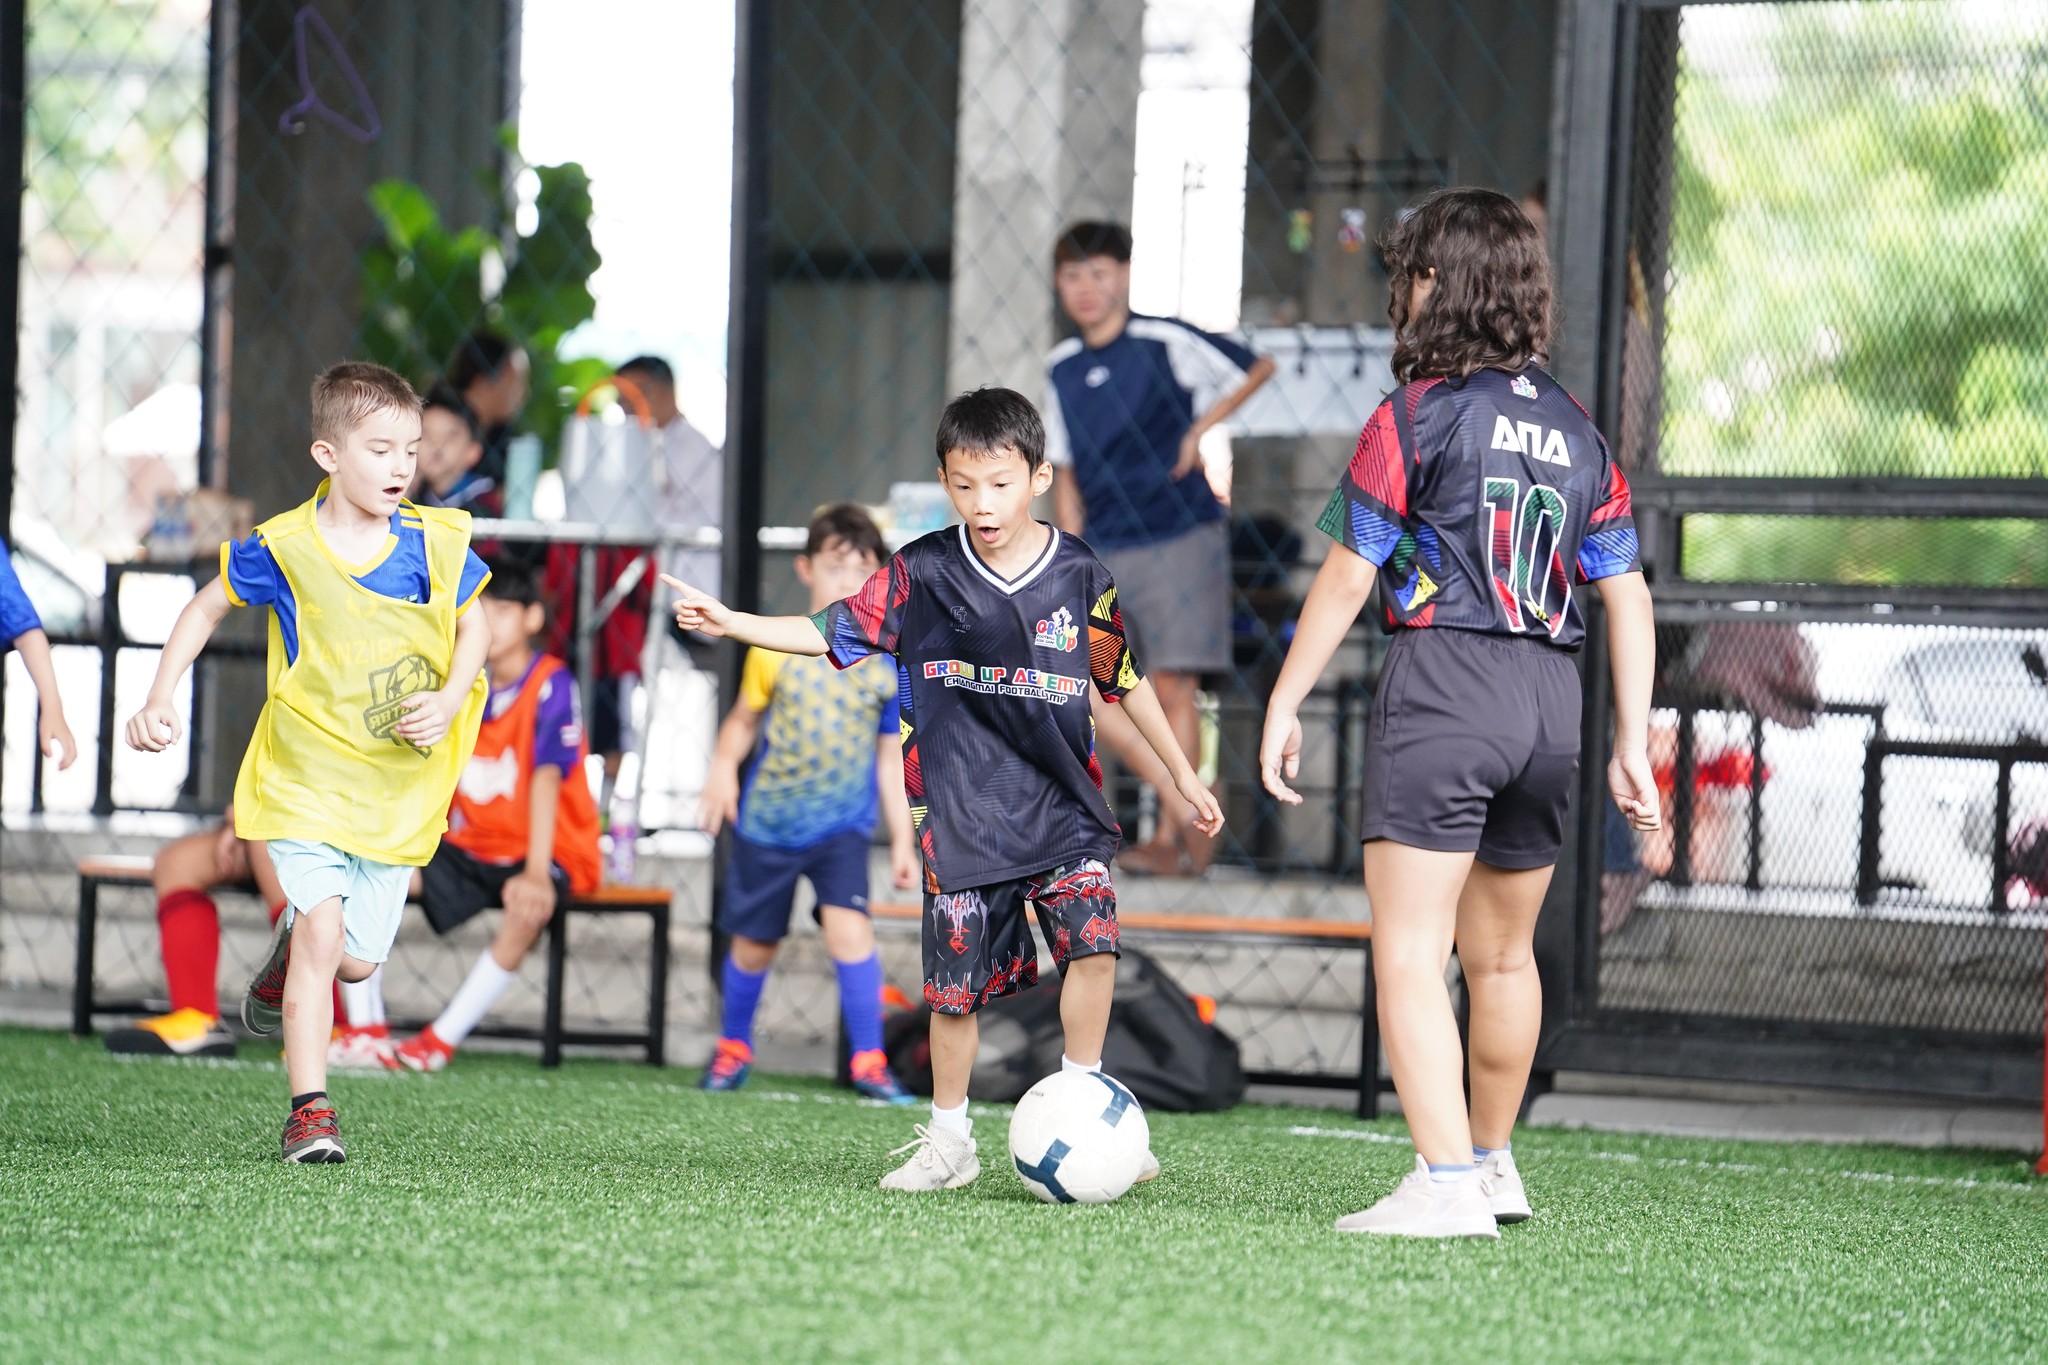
[1100,522,1231,673]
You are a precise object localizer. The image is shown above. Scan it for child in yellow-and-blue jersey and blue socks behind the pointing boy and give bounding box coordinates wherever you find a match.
[698,503,918,1105]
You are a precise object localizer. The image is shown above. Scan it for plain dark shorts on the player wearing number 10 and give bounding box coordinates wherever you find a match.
[1360,626,1579,870]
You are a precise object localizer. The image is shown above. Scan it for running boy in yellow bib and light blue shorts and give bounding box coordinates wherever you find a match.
[127,362,489,1162]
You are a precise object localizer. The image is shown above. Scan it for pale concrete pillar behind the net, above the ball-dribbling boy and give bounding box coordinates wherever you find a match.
[946,0,1145,395]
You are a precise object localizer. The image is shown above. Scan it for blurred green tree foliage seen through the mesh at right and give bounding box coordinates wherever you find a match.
[1659,0,2048,581]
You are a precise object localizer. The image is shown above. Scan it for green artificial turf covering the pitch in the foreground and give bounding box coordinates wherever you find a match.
[0,1029,2048,1363]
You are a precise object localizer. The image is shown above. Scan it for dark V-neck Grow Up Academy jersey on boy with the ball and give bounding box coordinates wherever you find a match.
[811,526,1141,892]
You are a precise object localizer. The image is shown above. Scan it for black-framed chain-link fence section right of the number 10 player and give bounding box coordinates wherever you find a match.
[1556,0,2048,1093]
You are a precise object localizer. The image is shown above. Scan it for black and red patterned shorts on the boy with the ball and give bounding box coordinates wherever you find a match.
[924,857,1116,1015]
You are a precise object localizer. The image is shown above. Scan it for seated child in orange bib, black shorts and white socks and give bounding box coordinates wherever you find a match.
[397,557,600,1072]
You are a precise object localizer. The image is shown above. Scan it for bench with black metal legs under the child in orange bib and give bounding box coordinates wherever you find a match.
[72,857,672,1066]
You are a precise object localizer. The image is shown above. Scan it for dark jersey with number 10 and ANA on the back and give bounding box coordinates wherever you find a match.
[1317,366,1640,649]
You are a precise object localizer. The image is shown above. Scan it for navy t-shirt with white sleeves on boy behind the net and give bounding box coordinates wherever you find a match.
[1044,313,1257,551]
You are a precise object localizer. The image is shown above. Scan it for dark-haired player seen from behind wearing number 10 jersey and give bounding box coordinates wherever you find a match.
[1260,190,1659,1238]
